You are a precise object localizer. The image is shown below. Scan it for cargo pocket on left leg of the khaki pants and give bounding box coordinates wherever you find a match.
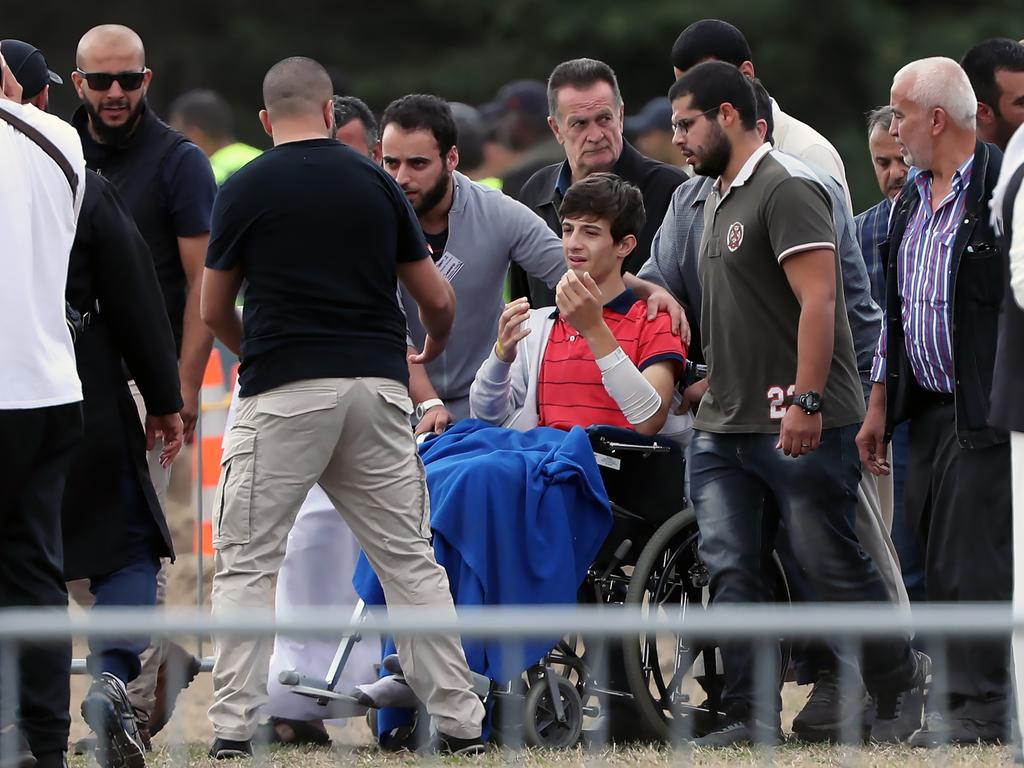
[213,427,256,550]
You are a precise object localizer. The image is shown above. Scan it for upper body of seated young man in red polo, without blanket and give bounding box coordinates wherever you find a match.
[469,173,684,434]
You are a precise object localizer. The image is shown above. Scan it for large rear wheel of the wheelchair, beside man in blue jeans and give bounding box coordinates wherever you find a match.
[624,508,790,740]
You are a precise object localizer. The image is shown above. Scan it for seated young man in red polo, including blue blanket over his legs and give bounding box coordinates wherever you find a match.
[353,173,685,741]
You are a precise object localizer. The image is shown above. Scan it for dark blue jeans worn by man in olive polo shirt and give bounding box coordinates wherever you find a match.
[690,425,915,720]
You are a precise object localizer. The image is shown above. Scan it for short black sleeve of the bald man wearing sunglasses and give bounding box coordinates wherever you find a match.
[162,141,217,238]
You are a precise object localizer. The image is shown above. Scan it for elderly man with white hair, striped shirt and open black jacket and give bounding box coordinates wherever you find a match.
[857,57,1013,746]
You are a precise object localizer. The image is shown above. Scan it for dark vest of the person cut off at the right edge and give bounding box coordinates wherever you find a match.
[990,164,1024,432]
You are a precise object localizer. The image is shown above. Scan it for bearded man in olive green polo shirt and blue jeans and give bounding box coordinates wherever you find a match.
[669,61,930,746]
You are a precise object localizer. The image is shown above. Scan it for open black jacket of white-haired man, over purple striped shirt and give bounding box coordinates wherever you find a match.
[881,141,1007,449]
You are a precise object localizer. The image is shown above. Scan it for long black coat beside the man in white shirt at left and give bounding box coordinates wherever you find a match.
[62,171,181,580]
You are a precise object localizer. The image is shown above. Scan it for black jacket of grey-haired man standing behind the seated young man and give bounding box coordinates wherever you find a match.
[509,141,686,307]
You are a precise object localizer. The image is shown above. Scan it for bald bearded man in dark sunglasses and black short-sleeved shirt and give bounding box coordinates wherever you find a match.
[72,25,217,753]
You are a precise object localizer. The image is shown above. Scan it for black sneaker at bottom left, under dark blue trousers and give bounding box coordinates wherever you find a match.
[82,672,145,768]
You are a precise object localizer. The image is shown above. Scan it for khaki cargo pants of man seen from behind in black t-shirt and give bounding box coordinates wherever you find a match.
[210,378,483,740]
